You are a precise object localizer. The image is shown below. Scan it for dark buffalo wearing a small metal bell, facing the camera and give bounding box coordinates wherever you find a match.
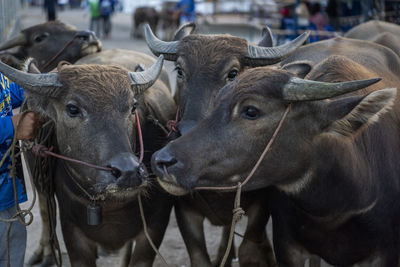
[0,58,176,266]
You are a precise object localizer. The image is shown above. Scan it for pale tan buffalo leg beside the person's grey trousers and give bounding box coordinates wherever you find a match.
[28,192,56,267]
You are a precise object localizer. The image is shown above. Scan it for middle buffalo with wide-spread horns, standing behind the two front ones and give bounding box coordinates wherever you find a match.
[145,24,308,266]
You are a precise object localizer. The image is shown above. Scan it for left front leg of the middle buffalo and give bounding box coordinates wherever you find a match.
[175,201,212,267]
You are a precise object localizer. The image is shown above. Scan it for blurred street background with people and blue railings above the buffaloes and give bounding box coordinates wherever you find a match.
[0,0,400,44]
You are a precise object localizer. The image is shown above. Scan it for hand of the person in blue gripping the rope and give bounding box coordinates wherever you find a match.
[11,112,42,140]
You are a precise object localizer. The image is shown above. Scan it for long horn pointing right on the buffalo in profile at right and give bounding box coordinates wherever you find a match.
[282,77,381,101]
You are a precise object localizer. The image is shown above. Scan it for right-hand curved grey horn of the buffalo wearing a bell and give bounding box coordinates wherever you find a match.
[128,55,164,94]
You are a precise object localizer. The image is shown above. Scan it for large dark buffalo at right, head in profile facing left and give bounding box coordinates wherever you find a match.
[152,67,400,267]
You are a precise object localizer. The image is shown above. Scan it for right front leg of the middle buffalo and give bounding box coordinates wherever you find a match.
[239,203,277,267]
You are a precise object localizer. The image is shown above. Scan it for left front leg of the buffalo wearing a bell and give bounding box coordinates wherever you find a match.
[61,220,97,267]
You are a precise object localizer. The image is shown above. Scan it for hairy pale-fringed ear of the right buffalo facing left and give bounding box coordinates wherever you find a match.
[323,88,397,136]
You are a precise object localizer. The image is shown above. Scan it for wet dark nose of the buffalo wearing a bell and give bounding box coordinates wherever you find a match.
[108,152,148,186]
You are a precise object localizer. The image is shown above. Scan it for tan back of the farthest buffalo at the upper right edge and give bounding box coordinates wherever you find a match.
[344,20,400,56]
